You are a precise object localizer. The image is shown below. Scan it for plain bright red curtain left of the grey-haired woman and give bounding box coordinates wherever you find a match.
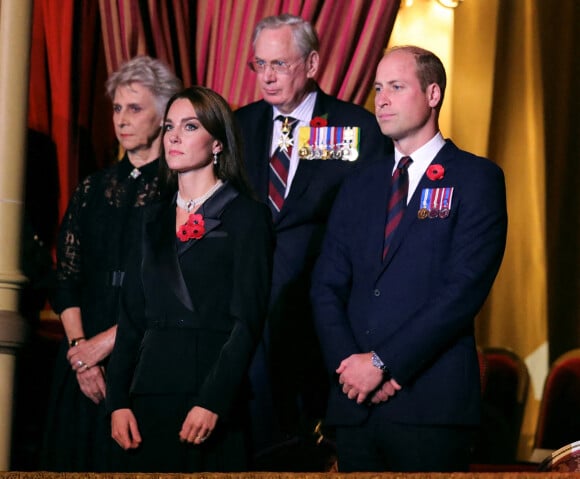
[28,0,114,227]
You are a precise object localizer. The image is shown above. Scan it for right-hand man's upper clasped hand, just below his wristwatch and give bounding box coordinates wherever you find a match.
[336,353,383,404]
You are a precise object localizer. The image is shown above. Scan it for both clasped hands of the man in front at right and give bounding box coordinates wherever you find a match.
[336,353,401,404]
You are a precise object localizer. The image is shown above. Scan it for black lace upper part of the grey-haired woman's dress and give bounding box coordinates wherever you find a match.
[53,157,158,334]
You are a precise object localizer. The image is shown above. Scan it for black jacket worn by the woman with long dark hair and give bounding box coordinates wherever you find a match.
[107,184,273,418]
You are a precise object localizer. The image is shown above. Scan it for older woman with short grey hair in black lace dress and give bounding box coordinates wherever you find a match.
[41,56,181,471]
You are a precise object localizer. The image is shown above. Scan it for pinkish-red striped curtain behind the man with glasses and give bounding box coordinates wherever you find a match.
[190,0,400,106]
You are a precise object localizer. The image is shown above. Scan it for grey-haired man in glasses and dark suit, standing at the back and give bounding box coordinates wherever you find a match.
[236,14,392,460]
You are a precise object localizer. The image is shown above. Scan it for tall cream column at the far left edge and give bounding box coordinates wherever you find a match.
[0,0,32,471]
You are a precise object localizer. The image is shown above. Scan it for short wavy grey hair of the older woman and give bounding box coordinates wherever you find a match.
[105,55,183,116]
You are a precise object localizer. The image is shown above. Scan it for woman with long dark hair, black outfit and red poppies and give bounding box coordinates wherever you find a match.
[107,86,273,472]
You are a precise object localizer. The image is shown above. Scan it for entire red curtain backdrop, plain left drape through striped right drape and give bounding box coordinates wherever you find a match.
[29,0,400,221]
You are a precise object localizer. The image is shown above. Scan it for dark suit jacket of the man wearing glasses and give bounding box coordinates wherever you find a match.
[236,89,392,352]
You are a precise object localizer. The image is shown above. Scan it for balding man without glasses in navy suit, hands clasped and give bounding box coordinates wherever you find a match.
[311,47,507,471]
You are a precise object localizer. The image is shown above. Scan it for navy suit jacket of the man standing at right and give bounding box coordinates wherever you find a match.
[312,140,507,424]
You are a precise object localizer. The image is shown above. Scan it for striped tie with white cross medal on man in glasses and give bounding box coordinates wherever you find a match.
[268,115,298,217]
